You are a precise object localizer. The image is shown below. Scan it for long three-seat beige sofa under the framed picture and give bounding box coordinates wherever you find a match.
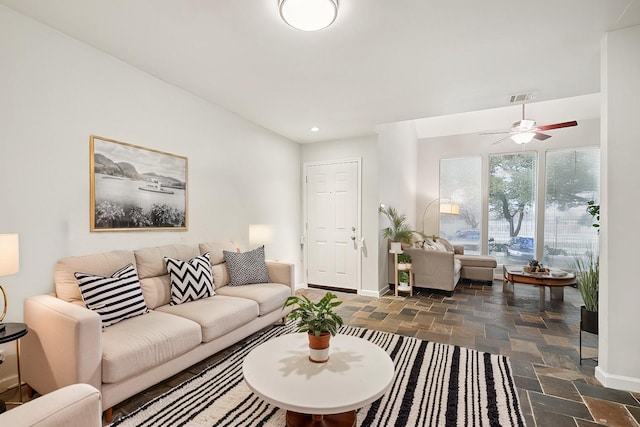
[22,242,294,419]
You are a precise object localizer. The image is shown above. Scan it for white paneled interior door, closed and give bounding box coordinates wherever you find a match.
[305,161,360,290]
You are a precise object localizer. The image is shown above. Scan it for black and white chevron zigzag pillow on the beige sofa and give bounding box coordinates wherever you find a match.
[164,252,215,305]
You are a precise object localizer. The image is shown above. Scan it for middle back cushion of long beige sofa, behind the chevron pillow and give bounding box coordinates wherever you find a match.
[134,245,200,310]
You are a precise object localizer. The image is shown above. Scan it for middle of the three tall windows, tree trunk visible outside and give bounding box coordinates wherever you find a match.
[488,152,537,264]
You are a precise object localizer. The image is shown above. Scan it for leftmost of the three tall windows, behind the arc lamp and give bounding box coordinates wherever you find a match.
[439,156,482,254]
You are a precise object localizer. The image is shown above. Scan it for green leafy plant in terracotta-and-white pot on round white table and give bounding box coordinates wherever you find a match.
[284,292,344,363]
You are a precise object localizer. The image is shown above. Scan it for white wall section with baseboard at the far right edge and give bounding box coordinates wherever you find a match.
[596,26,640,392]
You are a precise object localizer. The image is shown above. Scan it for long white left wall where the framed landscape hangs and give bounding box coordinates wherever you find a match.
[0,6,301,388]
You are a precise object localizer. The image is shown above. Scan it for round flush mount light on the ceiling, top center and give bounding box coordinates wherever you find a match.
[279,0,338,31]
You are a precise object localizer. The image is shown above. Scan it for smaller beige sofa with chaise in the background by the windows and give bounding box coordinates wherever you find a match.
[404,239,497,295]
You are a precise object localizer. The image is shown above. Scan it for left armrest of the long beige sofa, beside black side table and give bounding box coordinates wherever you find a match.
[20,295,102,394]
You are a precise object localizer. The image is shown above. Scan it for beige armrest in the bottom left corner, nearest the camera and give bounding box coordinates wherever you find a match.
[0,384,102,427]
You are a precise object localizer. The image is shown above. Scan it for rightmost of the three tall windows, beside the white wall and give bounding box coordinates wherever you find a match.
[543,148,600,269]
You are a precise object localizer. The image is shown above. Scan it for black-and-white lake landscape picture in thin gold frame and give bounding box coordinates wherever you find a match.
[89,135,188,231]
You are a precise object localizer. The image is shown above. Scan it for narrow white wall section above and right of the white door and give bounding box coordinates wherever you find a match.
[301,136,380,296]
